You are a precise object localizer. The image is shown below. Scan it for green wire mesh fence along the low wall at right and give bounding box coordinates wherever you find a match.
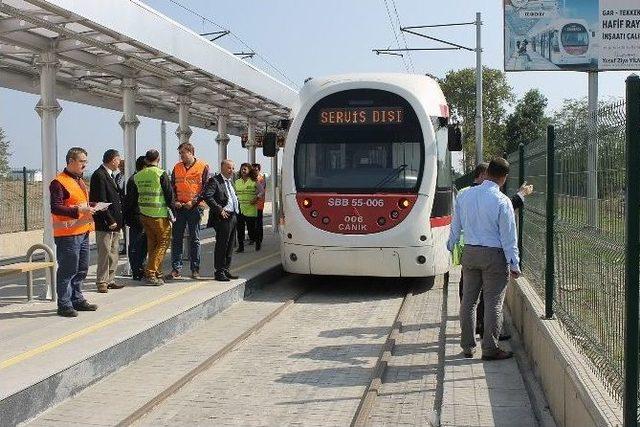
[507,102,626,400]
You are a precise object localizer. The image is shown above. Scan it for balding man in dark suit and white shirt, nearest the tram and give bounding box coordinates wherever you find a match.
[203,160,240,282]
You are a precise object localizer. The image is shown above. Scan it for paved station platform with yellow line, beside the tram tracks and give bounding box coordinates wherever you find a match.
[0,226,282,425]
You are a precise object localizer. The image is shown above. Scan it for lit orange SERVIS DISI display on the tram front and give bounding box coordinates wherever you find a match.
[318,107,404,126]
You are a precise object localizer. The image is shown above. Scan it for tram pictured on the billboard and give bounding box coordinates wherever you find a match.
[528,19,593,66]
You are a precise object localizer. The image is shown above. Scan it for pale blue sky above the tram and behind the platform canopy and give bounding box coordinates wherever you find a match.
[0,0,630,171]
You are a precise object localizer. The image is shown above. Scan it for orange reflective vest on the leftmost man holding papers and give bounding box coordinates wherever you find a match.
[51,172,95,237]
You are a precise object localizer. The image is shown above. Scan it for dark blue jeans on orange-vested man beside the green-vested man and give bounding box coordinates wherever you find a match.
[171,207,202,272]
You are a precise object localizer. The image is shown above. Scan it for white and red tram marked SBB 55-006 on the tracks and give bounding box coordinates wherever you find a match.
[280,74,461,277]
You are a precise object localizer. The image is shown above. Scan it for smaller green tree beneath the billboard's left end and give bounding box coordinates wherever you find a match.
[505,89,550,153]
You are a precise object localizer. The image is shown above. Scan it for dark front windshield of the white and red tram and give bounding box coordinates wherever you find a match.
[294,89,424,193]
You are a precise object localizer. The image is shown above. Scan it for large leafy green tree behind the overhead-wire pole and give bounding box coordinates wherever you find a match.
[439,67,513,171]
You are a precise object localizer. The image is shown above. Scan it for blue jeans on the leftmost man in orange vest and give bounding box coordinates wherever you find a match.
[54,233,89,309]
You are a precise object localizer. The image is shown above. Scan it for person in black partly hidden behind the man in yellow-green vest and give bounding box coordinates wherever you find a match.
[123,156,147,280]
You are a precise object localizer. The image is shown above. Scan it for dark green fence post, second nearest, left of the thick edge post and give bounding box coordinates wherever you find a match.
[544,126,556,319]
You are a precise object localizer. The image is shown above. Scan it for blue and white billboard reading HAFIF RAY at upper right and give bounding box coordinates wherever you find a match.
[504,0,640,71]
